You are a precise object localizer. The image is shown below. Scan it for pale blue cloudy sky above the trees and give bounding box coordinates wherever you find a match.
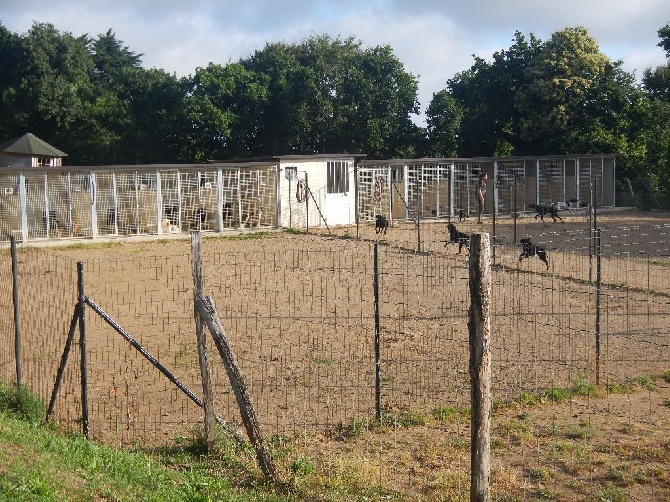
[0,0,670,121]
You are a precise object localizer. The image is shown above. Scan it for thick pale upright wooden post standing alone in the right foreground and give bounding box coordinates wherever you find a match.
[468,232,492,502]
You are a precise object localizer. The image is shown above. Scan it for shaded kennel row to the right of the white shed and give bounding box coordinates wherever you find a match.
[358,154,616,221]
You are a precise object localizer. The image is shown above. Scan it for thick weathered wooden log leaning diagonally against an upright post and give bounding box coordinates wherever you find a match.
[195,297,281,485]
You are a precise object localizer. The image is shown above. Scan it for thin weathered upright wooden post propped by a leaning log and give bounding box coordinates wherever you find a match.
[191,231,216,452]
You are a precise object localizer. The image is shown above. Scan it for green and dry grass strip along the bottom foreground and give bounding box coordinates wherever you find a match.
[0,374,670,502]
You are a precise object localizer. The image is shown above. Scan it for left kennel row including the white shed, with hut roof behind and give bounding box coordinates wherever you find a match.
[0,135,372,242]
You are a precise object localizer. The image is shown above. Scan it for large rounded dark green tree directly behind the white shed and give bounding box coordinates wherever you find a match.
[240,36,418,156]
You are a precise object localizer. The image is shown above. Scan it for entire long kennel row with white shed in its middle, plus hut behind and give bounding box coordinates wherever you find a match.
[0,135,616,242]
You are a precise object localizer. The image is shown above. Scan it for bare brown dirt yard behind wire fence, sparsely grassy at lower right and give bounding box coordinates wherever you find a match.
[11,207,670,500]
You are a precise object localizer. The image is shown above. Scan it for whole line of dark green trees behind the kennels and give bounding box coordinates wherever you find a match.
[0,22,670,197]
